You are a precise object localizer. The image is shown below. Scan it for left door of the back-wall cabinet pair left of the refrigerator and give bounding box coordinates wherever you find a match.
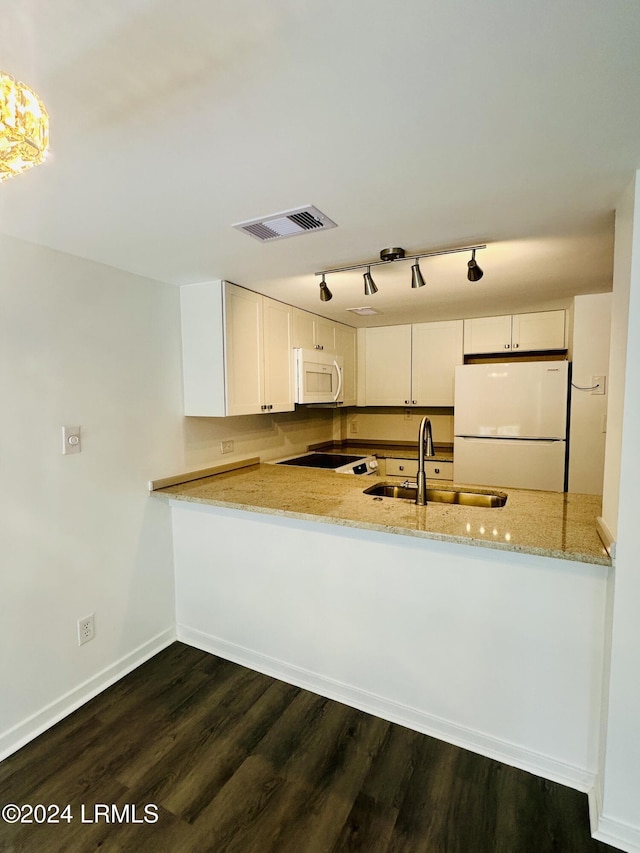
[365,325,411,406]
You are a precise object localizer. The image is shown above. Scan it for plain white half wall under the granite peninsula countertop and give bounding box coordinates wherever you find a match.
[172,502,608,790]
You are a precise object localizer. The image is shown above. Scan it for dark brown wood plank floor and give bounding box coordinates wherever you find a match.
[0,643,614,853]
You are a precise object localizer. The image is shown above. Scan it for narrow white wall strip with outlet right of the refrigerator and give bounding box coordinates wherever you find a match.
[569,293,611,495]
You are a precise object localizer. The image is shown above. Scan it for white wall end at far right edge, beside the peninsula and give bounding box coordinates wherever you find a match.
[599,173,640,850]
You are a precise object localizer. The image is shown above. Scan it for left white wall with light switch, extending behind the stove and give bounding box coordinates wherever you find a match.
[0,237,334,756]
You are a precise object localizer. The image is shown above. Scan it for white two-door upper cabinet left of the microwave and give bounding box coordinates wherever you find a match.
[180,281,294,417]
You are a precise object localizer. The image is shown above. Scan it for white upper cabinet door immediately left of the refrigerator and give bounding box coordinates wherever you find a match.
[411,320,463,406]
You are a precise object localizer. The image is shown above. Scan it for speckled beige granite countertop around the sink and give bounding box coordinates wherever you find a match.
[152,463,611,566]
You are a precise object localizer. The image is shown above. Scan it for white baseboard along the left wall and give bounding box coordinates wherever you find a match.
[0,628,176,761]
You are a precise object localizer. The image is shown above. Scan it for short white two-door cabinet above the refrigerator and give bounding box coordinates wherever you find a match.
[464,310,567,355]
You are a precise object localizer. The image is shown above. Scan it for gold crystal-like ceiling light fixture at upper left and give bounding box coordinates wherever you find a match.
[0,71,49,181]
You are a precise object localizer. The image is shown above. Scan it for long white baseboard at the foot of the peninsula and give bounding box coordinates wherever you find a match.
[177,625,595,792]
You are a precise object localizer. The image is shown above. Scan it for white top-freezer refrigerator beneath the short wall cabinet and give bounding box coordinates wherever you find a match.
[453,361,569,492]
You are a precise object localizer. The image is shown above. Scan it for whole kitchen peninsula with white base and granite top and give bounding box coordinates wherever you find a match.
[152,458,611,791]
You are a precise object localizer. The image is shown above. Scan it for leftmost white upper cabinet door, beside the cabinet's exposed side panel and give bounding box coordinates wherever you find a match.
[224,282,264,415]
